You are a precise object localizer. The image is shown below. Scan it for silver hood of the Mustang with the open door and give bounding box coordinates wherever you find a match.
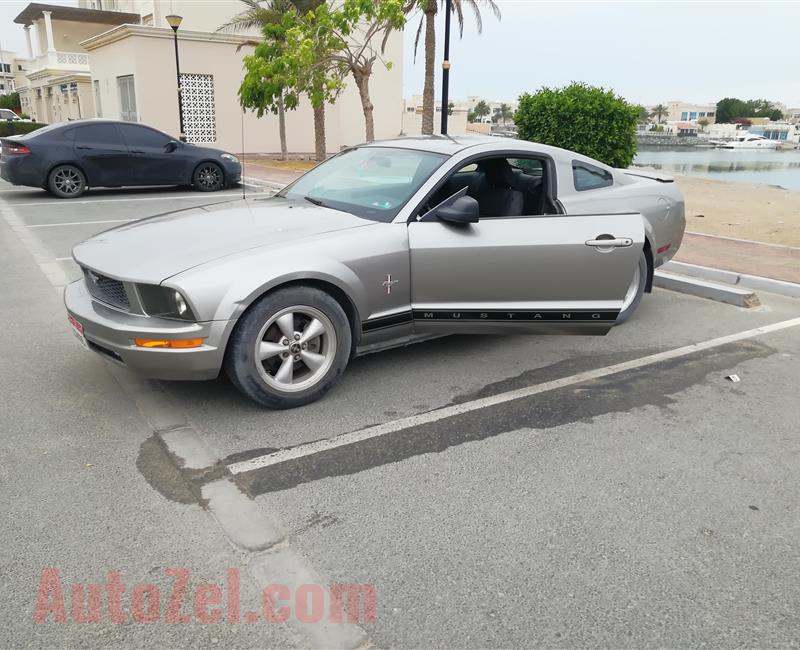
[72,198,375,284]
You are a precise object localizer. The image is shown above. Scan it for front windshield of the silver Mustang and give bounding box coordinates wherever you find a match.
[278,147,447,222]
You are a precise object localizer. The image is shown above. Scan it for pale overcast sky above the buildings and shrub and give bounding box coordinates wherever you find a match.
[0,0,800,107]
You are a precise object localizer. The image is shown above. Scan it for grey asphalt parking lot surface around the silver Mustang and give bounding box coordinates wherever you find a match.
[0,177,800,648]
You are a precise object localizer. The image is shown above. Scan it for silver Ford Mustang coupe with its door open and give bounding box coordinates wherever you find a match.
[64,137,685,408]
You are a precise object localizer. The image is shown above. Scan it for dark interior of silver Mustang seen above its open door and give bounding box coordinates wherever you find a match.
[427,157,557,218]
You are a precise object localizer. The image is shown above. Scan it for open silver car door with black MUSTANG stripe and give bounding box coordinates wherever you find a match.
[408,209,645,334]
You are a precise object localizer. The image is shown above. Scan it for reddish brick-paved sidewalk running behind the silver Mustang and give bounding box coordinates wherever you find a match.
[244,162,800,283]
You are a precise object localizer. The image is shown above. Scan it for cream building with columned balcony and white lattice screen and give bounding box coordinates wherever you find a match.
[14,0,403,153]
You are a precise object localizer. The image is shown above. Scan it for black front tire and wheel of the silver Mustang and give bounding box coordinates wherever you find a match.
[224,287,352,409]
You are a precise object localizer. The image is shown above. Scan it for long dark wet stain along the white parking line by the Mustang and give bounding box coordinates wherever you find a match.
[237,340,776,496]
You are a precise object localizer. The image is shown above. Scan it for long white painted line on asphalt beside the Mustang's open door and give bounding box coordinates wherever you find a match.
[228,318,800,474]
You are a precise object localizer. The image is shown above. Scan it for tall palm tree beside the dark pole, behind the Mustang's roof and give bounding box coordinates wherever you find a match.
[406,0,502,135]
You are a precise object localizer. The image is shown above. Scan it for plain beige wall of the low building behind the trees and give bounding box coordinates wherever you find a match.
[84,26,402,153]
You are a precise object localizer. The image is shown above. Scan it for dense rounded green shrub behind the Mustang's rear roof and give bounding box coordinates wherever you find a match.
[514,83,639,167]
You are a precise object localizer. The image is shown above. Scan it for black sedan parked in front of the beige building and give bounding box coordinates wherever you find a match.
[0,119,242,199]
